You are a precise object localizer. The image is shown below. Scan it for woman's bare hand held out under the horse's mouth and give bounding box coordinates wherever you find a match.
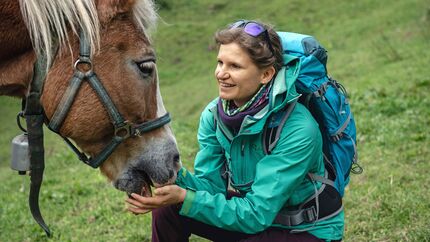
[126,185,187,215]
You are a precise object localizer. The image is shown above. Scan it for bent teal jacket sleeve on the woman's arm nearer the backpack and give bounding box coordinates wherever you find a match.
[180,107,322,234]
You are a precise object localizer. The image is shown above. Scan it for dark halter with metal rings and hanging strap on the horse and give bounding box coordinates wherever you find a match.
[24,34,170,237]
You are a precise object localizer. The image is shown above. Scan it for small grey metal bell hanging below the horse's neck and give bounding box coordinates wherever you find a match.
[10,133,30,175]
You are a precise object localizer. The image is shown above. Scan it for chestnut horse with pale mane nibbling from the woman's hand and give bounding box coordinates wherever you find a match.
[0,0,181,235]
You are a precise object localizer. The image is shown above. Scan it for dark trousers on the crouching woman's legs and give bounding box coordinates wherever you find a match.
[152,205,323,242]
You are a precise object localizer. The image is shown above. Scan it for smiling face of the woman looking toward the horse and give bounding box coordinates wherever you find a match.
[215,42,274,107]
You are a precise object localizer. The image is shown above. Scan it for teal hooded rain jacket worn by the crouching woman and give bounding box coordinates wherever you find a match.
[176,56,344,240]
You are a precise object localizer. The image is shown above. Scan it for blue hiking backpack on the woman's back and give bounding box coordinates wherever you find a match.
[263,32,363,197]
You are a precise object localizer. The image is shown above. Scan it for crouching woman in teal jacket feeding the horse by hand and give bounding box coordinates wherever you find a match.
[127,20,344,241]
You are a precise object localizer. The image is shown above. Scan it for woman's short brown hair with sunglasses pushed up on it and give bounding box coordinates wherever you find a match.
[215,20,283,72]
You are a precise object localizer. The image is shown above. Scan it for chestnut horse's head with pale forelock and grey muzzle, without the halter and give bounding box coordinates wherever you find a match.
[0,0,180,197]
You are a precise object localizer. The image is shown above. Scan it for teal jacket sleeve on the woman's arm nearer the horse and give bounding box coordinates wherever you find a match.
[176,104,226,194]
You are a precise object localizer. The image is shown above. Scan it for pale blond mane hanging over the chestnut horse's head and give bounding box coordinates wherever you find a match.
[19,0,157,64]
